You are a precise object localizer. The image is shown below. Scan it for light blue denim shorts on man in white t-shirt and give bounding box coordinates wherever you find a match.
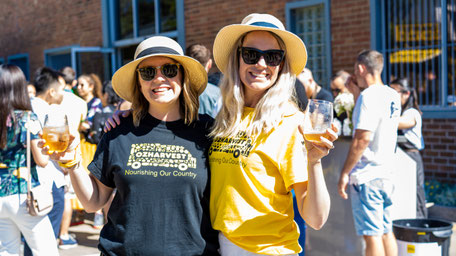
[350,179,394,236]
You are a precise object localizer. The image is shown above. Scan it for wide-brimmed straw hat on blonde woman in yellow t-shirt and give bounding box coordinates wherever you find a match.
[214,13,307,75]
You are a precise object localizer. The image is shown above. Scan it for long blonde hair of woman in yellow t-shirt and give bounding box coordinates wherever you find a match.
[210,32,297,137]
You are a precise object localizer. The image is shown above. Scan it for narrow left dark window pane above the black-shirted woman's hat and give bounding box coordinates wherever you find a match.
[117,0,133,39]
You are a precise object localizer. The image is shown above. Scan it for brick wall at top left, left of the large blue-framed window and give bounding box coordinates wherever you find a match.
[0,0,102,76]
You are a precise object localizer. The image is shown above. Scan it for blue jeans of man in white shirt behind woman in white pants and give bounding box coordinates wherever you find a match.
[24,183,65,256]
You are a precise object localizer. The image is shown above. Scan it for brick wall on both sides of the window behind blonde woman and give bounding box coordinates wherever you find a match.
[185,0,370,75]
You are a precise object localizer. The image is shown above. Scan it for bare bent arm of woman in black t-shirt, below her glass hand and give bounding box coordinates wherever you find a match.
[67,163,113,213]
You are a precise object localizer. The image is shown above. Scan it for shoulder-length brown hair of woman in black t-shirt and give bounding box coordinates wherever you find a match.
[131,58,199,127]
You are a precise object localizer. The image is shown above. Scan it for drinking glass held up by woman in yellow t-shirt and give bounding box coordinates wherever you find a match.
[304,100,333,142]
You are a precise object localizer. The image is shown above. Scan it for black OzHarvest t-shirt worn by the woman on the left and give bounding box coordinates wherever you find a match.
[88,115,218,255]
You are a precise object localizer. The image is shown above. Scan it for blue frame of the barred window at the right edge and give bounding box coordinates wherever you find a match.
[370,0,456,119]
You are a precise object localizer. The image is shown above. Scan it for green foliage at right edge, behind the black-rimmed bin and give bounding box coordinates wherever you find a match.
[424,180,456,207]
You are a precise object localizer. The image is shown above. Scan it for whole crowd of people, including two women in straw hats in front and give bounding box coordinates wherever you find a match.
[0,13,427,256]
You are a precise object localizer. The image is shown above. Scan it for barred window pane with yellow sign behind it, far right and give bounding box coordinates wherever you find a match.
[383,0,445,106]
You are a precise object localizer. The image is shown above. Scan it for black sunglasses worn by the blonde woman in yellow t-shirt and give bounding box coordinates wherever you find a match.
[239,47,285,67]
